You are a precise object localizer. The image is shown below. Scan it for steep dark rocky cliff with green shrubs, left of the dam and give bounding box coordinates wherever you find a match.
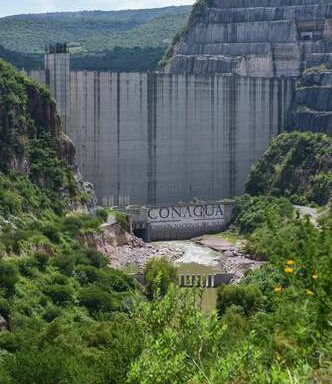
[0,61,91,213]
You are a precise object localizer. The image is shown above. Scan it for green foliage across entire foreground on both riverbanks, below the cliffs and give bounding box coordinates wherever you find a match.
[0,204,332,384]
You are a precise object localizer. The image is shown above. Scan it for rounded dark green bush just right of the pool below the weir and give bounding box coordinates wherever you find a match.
[217,285,263,316]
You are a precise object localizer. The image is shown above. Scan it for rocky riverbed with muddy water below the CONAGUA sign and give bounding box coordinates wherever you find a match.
[104,228,262,311]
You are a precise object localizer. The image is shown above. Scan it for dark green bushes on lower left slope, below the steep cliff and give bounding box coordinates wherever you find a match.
[0,215,140,384]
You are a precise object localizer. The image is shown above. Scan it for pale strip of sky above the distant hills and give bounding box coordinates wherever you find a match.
[0,0,194,17]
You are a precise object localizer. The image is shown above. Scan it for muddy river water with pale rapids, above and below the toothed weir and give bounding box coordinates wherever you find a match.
[155,240,223,312]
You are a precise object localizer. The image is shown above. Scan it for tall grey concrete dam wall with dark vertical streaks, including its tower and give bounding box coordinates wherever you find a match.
[28,45,295,205]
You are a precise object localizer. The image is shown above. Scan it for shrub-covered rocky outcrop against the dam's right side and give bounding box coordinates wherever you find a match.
[246,132,332,205]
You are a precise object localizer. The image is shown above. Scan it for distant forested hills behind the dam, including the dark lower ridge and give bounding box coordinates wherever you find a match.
[0,6,191,71]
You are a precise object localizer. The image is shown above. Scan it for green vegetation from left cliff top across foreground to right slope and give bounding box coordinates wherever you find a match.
[0,62,332,384]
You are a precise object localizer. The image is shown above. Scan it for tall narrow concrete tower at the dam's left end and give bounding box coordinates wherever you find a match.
[45,43,70,132]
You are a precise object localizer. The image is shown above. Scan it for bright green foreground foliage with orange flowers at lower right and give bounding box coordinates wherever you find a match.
[129,210,332,384]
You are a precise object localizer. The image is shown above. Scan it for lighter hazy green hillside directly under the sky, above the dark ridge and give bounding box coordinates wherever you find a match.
[0,6,191,53]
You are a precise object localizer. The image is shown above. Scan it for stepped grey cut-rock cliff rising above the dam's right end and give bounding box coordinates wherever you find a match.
[164,0,332,77]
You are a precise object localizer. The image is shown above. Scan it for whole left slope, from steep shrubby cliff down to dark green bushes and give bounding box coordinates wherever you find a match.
[0,62,139,384]
